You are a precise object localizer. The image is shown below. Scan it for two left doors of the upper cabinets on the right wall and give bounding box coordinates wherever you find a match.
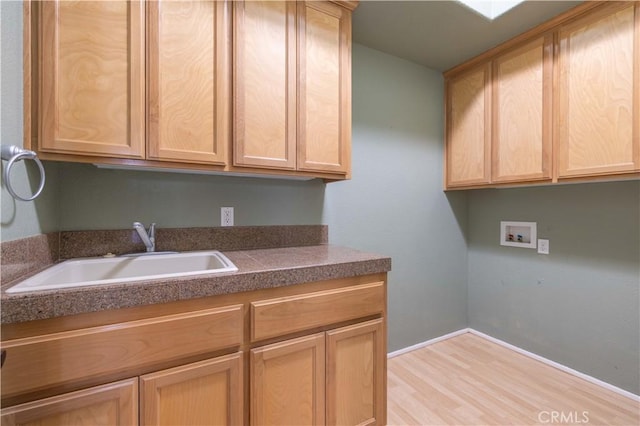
[446,36,553,188]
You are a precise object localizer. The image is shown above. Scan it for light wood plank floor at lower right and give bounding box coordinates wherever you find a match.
[387,333,640,426]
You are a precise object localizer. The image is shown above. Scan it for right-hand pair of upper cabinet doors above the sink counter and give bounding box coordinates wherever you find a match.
[233,1,351,175]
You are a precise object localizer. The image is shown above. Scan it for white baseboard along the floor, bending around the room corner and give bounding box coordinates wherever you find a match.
[387,328,640,402]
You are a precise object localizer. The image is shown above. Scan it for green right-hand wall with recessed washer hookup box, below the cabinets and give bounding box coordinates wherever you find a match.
[467,181,640,394]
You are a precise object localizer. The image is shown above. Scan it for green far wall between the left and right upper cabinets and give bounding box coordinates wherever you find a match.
[324,45,467,351]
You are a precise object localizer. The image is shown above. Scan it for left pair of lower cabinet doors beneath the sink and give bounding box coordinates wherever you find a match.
[1,353,243,426]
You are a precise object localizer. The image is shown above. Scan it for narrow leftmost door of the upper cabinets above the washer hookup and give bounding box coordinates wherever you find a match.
[446,64,491,187]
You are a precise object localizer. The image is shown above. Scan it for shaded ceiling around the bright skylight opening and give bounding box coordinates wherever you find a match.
[353,0,582,71]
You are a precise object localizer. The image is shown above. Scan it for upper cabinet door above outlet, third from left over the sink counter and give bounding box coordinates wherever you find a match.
[233,1,297,170]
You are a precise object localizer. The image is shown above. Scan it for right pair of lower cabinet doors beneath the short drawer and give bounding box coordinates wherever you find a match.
[250,319,386,425]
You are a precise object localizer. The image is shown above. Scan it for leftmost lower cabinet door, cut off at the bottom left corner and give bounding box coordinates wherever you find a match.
[1,378,138,426]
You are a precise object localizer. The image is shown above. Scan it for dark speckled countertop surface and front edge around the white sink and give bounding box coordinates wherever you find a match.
[0,244,391,324]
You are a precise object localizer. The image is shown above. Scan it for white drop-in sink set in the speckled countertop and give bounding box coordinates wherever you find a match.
[6,251,238,293]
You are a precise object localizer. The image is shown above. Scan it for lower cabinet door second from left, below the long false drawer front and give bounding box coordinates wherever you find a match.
[140,353,243,426]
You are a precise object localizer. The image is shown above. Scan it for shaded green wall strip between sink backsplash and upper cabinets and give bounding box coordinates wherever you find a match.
[59,164,325,230]
